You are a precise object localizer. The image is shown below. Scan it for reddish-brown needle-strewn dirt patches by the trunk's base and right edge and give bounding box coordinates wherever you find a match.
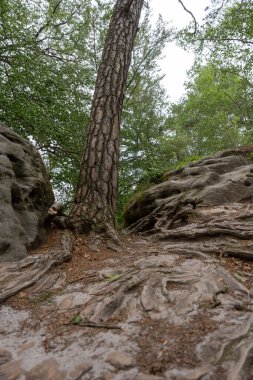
[30,229,253,288]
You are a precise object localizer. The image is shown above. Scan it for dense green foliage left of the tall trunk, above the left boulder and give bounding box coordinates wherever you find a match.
[0,0,111,200]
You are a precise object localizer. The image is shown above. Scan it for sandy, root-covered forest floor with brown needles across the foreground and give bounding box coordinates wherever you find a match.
[0,230,253,380]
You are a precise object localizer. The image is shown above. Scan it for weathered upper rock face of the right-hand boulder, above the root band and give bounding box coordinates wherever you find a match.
[125,145,253,232]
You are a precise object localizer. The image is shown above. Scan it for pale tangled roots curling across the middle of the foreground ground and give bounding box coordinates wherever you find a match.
[75,254,248,323]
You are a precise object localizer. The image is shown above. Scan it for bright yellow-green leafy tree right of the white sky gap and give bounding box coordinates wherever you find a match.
[168,64,244,160]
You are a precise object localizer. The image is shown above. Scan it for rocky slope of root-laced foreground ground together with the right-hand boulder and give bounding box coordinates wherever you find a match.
[0,146,253,380]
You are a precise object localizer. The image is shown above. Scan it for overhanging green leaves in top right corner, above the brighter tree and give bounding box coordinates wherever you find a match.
[197,0,253,73]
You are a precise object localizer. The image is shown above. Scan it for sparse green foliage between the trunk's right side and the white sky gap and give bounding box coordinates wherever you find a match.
[118,11,173,220]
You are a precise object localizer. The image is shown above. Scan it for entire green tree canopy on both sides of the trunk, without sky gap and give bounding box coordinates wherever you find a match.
[0,0,253,224]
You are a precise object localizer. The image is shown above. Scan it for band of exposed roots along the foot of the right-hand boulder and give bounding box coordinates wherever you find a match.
[123,202,253,260]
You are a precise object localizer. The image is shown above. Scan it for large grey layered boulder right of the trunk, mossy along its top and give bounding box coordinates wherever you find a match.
[125,145,253,239]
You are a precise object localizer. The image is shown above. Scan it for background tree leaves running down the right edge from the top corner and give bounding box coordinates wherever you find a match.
[196,0,253,143]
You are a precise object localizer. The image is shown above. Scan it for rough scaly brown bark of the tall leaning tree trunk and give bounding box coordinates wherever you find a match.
[71,0,143,232]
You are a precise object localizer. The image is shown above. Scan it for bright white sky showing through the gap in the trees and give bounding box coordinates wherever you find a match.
[150,0,211,101]
